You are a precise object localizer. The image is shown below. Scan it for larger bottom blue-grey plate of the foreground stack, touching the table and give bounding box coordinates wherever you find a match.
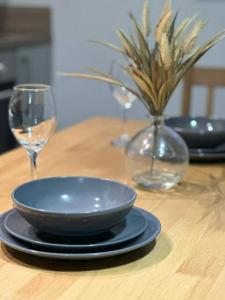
[0,210,161,260]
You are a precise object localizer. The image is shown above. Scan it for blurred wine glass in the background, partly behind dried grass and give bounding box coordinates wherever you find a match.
[109,61,136,147]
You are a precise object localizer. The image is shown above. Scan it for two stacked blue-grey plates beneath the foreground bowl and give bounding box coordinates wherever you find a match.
[0,207,161,260]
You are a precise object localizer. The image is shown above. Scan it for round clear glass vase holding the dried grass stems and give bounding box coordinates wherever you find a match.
[125,116,189,190]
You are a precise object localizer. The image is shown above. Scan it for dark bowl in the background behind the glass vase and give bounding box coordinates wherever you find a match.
[165,117,225,148]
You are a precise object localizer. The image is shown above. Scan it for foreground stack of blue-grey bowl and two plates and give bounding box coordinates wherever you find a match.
[0,177,161,260]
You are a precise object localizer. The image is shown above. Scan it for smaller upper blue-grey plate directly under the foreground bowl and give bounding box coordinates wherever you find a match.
[4,208,147,250]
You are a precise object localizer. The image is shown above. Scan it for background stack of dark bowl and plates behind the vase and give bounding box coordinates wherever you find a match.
[166,117,225,162]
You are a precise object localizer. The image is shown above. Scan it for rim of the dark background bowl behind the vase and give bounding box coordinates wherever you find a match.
[165,116,225,135]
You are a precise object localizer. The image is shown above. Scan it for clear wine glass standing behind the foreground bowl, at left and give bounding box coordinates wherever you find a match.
[9,84,56,179]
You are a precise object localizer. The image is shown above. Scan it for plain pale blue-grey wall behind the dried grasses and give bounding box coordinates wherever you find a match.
[8,0,225,127]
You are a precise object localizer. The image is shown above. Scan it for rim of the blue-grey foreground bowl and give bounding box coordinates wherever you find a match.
[11,176,137,217]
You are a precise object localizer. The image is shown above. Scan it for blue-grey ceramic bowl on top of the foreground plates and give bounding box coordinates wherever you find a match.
[12,177,136,236]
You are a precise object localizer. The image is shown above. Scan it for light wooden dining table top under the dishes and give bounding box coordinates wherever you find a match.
[0,118,225,300]
